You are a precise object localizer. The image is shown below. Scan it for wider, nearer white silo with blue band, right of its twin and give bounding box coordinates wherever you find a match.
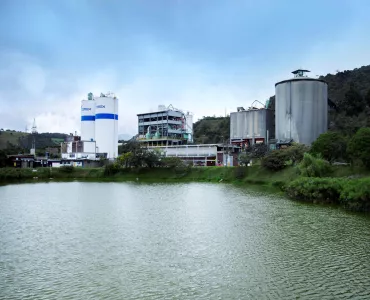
[95,97,118,159]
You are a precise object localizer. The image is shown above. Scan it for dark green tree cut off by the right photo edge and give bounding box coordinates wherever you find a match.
[347,127,370,169]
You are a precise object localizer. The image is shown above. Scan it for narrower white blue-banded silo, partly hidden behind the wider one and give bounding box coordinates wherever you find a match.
[81,100,95,141]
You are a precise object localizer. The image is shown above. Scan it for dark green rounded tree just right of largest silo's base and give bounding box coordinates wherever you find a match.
[310,131,347,163]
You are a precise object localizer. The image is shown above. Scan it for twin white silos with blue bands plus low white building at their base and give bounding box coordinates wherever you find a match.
[61,93,118,160]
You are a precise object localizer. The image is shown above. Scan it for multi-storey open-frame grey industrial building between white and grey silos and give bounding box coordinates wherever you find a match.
[136,105,193,146]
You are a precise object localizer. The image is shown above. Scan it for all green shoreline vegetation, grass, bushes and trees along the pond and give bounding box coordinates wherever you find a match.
[0,128,370,212]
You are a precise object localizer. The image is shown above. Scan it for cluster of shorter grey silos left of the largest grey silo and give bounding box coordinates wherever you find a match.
[230,101,275,148]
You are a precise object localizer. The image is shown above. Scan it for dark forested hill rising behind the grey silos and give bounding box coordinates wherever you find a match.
[194,65,370,143]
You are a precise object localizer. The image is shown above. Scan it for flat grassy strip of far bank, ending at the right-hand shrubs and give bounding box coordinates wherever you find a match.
[0,166,295,185]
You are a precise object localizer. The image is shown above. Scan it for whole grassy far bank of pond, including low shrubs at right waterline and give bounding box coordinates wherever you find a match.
[0,165,370,212]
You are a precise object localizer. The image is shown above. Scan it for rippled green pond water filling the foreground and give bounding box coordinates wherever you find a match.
[0,182,370,300]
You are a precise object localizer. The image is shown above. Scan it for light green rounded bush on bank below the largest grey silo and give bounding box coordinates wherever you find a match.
[298,153,332,177]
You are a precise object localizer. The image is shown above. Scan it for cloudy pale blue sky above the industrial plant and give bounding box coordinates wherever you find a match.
[0,0,370,135]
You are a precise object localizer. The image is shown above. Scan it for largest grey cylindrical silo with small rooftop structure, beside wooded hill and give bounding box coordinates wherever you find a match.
[275,69,328,145]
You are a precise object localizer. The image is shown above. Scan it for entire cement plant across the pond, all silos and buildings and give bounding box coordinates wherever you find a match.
[5,69,330,167]
